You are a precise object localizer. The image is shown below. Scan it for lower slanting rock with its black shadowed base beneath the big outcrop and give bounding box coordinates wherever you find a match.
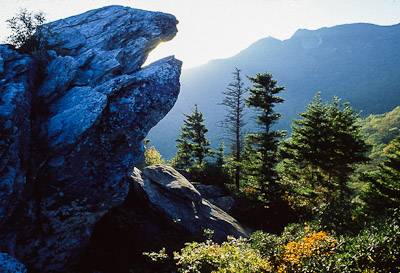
[80,165,247,273]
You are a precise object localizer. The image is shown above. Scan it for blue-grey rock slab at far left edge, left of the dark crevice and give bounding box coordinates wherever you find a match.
[0,45,34,232]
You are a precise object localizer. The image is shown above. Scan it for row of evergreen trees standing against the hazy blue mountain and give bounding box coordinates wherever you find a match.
[148,68,399,231]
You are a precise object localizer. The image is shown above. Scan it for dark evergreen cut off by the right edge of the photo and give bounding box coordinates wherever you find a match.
[365,136,400,210]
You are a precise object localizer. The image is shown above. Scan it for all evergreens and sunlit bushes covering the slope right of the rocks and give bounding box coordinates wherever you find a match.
[145,69,400,272]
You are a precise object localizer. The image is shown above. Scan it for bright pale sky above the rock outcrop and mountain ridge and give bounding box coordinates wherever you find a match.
[0,0,400,68]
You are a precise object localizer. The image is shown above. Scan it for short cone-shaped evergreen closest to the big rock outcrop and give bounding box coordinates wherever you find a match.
[173,104,213,168]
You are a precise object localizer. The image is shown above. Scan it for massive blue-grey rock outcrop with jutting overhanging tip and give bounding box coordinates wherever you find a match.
[0,6,181,272]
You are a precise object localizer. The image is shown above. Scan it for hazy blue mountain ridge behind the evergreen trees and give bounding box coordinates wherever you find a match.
[148,23,400,158]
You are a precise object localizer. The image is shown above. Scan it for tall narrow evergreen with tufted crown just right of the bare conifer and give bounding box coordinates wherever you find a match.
[246,72,285,194]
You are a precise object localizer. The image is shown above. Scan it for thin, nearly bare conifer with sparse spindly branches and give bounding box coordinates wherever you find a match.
[221,68,246,189]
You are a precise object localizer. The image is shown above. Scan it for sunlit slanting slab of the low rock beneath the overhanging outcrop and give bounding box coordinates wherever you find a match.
[132,165,247,242]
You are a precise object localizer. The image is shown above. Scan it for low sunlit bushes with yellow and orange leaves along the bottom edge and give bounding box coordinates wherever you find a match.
[148,210,400,273]
